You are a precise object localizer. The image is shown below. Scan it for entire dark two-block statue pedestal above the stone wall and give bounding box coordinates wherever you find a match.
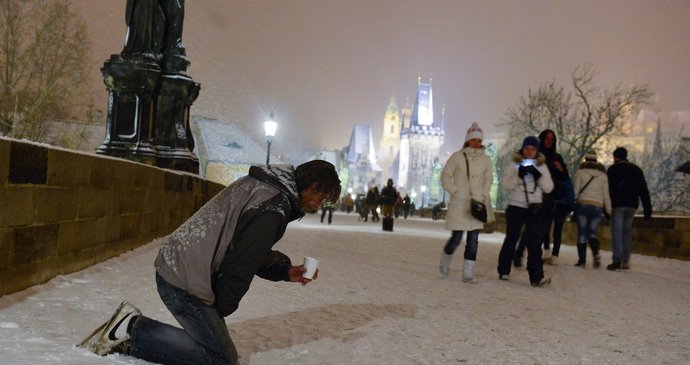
[96,55,201,173]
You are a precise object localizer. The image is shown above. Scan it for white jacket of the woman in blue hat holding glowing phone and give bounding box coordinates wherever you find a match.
[501,153,553,208]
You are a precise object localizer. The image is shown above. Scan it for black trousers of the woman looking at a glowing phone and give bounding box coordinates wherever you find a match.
[498,204,545,284]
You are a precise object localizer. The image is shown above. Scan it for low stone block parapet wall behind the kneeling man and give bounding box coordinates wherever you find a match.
[0,138,224,295]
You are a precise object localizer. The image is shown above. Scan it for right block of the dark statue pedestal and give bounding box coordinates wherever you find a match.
[155,74,201,173]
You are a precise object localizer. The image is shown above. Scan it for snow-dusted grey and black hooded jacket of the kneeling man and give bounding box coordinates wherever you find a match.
[155,165,304,316]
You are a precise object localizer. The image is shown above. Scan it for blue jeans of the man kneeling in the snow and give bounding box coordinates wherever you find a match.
[130,274,237,365]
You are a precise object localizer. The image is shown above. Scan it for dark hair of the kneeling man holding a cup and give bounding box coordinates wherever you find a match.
[295,160,340,205]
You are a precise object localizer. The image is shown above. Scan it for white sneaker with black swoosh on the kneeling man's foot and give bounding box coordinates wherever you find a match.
[77,301,141,356]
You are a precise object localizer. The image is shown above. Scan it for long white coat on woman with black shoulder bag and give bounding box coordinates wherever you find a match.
[441,147,495,231]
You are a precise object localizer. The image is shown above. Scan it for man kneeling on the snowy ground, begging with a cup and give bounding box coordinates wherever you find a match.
[80,160,340,364]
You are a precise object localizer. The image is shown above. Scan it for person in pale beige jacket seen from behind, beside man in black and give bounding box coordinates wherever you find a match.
[575,150,611,269]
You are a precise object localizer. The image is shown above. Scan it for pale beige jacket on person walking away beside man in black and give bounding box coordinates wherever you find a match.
[575,162,611,214]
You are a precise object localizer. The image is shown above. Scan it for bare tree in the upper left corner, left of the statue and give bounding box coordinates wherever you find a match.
[0,0,90,141]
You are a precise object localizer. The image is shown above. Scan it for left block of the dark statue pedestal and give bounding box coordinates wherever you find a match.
[96,55,161,165]
